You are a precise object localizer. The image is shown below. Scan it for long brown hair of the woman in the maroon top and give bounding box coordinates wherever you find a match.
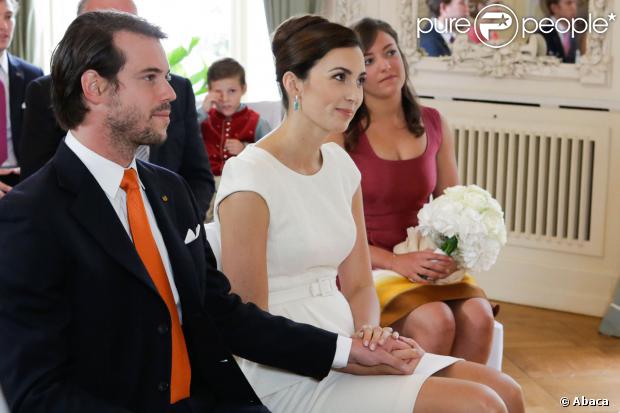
[344,17,424,152]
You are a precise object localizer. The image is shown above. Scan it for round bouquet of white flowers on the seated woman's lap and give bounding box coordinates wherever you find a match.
[394,185,506,284]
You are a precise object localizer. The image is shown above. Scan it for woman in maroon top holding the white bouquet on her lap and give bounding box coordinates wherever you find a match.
[334,18,493,363]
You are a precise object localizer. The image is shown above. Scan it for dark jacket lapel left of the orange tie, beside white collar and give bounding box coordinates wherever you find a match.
[53,142,159,295]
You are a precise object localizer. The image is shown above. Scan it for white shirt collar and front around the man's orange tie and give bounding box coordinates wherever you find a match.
[65,131,183,322]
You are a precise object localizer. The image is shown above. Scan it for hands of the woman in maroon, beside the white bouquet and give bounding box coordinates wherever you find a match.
[392,250,457,284]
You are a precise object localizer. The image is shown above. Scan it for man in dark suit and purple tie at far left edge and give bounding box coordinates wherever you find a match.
[0,0,43,198]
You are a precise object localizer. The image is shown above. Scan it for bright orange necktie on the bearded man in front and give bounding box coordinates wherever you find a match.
[121,168,192,403]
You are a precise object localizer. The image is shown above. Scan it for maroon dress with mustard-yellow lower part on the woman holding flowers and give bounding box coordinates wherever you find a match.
[350,107,486,325]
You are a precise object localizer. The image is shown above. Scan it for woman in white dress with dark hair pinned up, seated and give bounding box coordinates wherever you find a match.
[215,16,523,413]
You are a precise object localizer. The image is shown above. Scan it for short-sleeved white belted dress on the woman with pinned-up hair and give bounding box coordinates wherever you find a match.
[215,143,458,413]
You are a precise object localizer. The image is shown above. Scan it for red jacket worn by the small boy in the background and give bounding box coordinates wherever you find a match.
[200,107,259,176]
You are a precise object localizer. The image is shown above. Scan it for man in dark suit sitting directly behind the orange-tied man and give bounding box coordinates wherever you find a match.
[21,0,215,215]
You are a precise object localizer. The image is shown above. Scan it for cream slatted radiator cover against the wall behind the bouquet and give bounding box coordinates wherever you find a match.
[422,100,620,315]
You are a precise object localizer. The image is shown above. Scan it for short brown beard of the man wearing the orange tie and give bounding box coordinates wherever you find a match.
[106,101,170,150]
